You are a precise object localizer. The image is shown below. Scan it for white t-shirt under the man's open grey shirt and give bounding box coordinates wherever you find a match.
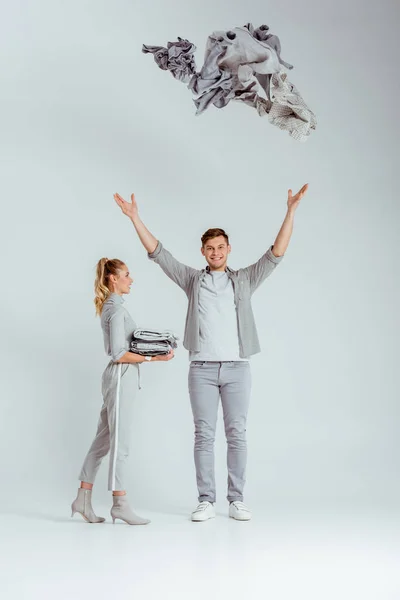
[189,271,246,362]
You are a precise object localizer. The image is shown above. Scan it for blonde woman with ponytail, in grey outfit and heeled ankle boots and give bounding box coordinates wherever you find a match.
[71,258,174,525]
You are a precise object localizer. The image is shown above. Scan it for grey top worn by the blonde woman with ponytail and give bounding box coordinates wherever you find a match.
[101,294,136,361]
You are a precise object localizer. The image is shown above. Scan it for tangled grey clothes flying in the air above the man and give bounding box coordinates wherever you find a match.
[142,23,317,141]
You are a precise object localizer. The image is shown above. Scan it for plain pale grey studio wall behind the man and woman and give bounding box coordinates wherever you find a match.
[0,0,400,511]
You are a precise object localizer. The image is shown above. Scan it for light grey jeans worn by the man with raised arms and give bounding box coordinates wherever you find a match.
[189,361,251,502]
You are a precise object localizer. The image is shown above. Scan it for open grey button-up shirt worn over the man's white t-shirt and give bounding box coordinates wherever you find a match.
[148,242,283,358]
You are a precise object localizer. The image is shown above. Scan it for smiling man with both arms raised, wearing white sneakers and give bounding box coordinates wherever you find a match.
[114,184,308,521]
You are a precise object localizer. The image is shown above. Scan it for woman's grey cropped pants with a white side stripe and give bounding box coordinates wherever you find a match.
[79,362,139,491]
